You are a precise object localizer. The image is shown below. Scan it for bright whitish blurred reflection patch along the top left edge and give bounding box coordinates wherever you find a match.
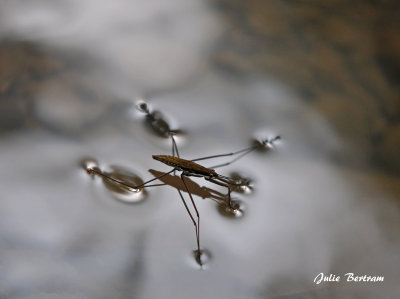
[0,0,221,91]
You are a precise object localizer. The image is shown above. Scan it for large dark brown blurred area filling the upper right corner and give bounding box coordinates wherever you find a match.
[215,0,400,175]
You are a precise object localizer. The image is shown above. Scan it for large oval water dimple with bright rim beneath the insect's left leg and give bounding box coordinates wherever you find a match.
[102,166,147,203]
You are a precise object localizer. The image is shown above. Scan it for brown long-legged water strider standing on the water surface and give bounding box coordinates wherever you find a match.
[85,101,280,266]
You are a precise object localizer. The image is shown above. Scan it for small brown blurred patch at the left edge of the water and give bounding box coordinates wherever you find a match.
[0,40,62,134]
